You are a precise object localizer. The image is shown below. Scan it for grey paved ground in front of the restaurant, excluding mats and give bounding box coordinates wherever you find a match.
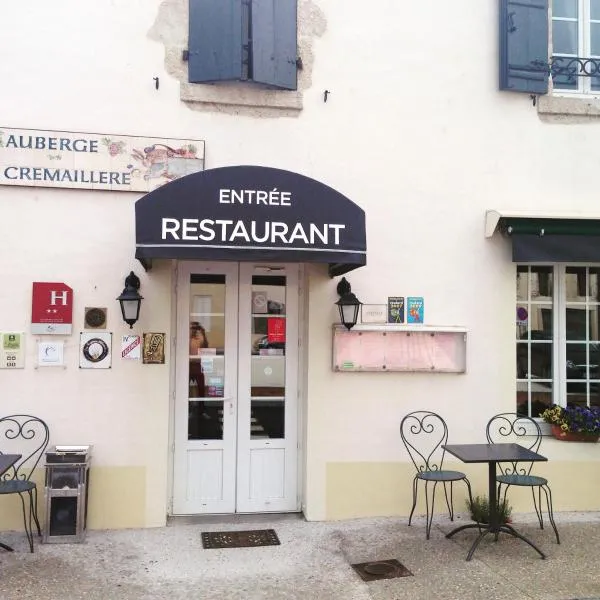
[0,513,600,600]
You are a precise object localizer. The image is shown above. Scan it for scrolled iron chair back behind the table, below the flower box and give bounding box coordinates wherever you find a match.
[485,413,542,475]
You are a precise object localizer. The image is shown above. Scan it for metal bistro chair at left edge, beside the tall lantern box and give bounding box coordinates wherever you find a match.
[0,415,50,552]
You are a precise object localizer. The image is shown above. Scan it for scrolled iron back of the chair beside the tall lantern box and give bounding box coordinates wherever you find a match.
[0,415,50,483]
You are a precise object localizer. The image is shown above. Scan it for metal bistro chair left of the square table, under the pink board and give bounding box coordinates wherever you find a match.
[400,411,473,539]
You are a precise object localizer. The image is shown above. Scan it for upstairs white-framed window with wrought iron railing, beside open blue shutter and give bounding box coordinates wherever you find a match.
[550,0,600,95]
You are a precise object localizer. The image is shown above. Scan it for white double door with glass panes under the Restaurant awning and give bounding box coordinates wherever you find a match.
[173,262,299,515]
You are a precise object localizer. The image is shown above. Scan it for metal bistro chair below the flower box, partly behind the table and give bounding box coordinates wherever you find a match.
[485,413,560,544]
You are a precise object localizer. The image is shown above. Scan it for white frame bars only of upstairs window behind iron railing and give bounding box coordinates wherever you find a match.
[549,0,600,98]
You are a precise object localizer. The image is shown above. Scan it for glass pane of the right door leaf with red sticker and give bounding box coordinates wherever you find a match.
[250,275,286,439]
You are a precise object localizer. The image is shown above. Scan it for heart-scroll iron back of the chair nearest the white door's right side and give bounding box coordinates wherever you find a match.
[400,410,448,473]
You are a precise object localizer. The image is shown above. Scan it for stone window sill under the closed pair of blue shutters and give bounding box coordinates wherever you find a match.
[180,83,302,111]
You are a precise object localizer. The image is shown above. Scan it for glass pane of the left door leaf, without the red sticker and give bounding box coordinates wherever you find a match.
[188,275,225,440]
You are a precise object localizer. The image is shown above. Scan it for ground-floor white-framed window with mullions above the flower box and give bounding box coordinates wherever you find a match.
[516,264,600,418]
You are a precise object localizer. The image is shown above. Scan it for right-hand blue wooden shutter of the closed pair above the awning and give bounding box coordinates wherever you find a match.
[251,0,298,90]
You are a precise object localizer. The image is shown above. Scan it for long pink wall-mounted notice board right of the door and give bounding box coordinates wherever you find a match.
[333,328,467,373]
